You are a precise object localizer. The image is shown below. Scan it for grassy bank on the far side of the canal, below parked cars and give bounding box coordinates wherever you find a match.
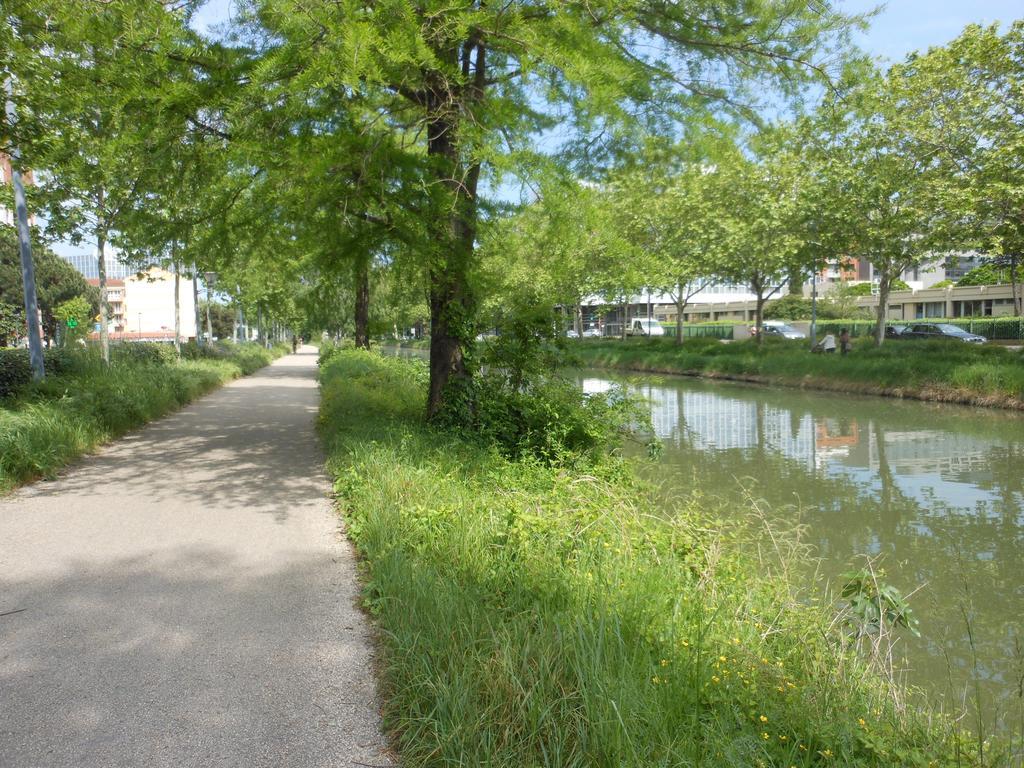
[571,339,1024,409]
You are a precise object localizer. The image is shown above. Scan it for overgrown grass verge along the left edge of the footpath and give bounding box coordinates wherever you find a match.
[0,344,286,494]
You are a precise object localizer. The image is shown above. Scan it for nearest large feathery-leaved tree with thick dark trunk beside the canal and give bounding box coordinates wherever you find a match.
[241,0,864,417]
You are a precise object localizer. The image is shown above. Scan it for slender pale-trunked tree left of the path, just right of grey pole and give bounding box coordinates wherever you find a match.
[8,0,211,360]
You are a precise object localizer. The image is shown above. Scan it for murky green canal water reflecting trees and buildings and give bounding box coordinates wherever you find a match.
[580,371,1024,729]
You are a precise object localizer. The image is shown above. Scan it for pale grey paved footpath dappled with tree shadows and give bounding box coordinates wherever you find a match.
[0,347,390,768]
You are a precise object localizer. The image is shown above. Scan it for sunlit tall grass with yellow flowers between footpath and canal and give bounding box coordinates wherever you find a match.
[321,351,995,768]
